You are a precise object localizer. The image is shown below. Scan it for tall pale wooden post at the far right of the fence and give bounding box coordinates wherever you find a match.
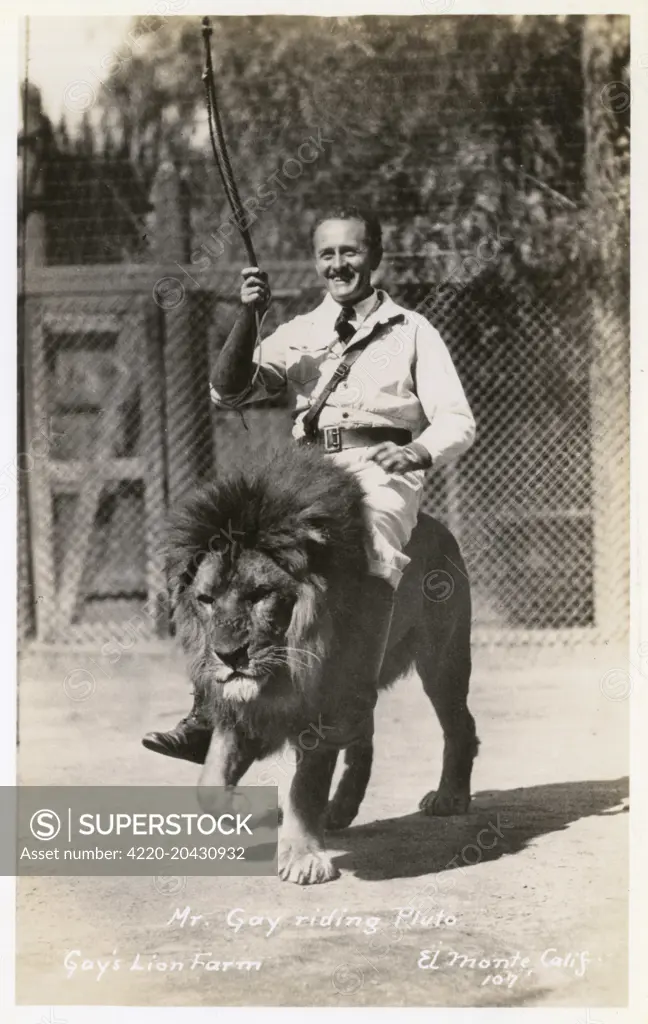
[581,15,630,641]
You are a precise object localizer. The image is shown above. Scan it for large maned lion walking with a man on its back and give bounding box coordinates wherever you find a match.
[167,446,478,885]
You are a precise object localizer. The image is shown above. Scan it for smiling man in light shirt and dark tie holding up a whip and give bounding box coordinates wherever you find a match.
[143,206,475,762]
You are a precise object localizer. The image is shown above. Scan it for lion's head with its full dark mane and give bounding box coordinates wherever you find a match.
[167,447,368,715]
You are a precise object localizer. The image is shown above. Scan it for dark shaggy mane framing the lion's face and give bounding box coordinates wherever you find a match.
[167,446,369,731]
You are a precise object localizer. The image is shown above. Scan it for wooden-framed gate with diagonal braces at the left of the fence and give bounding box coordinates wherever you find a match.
[25,289,168,643]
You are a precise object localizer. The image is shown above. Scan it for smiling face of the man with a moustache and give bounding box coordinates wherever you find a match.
[313,218,380,305]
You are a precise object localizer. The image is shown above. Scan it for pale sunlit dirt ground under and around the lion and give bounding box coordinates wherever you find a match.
[16,647,630,1007]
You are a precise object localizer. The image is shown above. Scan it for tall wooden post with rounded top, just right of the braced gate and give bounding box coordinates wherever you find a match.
[150,161,213,506]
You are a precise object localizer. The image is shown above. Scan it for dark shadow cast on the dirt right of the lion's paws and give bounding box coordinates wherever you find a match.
[328,777,629,881]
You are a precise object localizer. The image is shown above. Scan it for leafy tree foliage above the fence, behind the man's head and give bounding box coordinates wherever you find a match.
[44,16,628,273]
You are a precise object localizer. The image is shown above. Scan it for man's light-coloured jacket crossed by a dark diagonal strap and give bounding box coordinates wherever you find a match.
[211,290,475,466]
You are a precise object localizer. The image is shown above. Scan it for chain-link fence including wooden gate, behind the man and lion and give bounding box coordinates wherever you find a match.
[20,249,629,644]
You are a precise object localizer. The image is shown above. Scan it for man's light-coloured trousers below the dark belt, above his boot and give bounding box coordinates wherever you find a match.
[329,447,425,589]
